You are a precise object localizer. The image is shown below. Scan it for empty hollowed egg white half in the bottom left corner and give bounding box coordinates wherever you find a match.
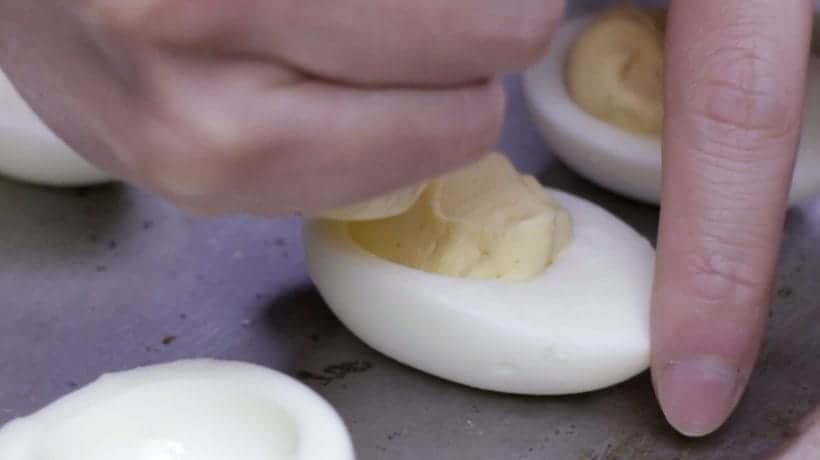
[0,360,354,460]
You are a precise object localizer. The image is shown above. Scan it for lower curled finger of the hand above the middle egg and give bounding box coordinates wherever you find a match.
[127,73,504,215]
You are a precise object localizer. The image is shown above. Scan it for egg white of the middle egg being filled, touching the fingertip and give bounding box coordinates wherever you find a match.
[305,191,655,395]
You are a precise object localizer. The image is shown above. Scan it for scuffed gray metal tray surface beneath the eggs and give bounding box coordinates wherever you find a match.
[0,74,820,460]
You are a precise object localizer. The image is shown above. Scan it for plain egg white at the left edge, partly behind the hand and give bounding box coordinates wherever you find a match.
[0,71,111,186]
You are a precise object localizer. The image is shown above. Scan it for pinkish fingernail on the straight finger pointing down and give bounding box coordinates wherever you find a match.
[657,356,742,436]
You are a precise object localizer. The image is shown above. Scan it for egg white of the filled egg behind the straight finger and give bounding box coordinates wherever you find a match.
[524,18,820,204]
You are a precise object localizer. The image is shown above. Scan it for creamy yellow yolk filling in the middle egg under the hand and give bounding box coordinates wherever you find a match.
[347,154,572,280]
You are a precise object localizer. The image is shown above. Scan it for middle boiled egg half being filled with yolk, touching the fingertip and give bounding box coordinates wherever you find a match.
[304,154,654,395]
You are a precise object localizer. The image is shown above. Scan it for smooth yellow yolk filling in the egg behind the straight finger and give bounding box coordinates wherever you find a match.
[564,5,665,135]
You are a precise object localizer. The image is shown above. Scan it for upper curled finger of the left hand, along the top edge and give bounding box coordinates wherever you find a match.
[89,0,564,86]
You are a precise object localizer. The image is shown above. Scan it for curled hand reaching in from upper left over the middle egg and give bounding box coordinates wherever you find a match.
[0,0,563,215]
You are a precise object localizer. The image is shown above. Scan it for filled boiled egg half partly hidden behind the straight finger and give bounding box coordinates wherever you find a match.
[524,5,820,204]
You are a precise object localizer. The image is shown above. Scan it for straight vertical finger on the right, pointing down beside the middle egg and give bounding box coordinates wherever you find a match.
[652,0,812,436]
